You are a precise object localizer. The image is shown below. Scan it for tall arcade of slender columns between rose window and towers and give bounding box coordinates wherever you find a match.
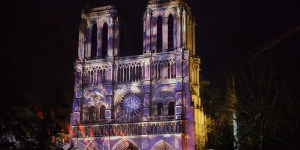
[75,51,183,86]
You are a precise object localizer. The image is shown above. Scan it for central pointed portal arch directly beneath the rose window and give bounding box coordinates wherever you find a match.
[112,138,139,150]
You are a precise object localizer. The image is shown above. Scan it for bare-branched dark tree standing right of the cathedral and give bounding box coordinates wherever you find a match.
[233,55,289,150]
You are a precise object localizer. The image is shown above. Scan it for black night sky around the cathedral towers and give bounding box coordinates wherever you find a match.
[0,0,300,109]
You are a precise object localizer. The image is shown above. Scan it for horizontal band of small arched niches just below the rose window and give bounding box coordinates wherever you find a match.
[71,120,184,138]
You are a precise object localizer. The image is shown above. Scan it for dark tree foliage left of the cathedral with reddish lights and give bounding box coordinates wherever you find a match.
[0,102,63,149]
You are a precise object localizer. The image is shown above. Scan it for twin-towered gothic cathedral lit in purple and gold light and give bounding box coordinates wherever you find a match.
[70,0,205,150]
